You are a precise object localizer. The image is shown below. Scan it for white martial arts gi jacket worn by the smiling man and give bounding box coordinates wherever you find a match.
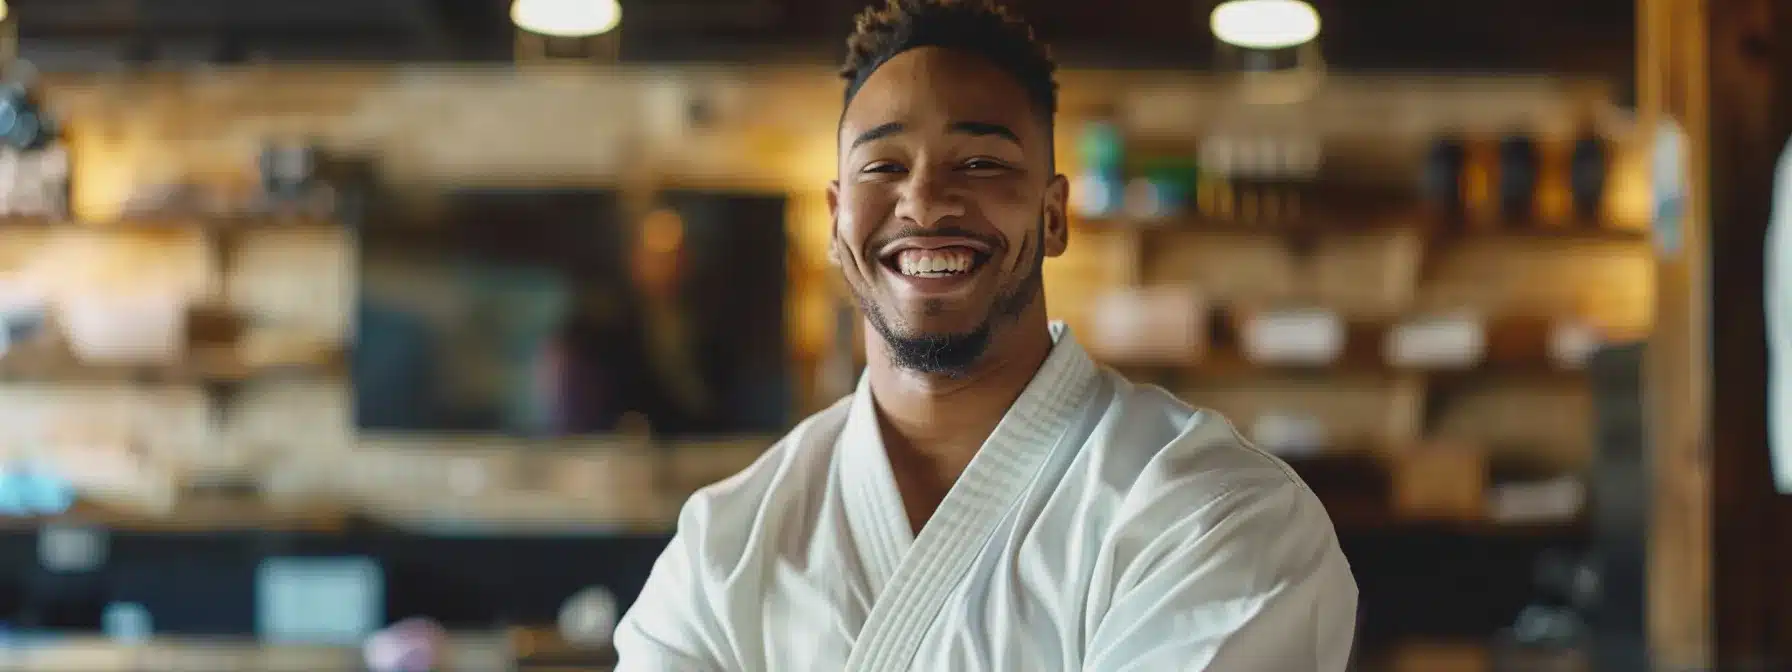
[616,324,1357,672]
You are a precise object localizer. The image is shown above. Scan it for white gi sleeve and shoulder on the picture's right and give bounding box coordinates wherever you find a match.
[1084,426,1357,672]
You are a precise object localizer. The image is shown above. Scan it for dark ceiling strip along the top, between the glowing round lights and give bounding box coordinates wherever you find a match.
[11,0,1636,79]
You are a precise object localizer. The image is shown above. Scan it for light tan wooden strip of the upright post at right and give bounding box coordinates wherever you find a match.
[1638,0,1711,670]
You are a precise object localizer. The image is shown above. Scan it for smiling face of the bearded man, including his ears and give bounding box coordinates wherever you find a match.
[828,47,1068,375]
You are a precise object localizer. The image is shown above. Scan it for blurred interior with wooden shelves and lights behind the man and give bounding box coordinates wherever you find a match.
[0,0,1770,672]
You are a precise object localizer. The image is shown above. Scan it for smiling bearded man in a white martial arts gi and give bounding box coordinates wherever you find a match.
[616,0,1357,672]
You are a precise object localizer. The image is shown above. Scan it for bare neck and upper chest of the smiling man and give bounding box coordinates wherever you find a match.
[866,310,1052,486]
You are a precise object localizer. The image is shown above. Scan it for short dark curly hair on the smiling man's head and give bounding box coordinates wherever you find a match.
[840,0,1057,120]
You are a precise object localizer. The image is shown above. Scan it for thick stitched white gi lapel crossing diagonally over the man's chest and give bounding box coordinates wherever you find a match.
[846,323,1097,672]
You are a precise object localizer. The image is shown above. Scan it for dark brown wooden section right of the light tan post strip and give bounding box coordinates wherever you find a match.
[1702,0,1792,670]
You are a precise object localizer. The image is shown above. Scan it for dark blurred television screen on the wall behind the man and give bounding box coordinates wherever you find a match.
[353,190,790,437]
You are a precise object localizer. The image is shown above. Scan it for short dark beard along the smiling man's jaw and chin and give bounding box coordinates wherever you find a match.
[848,220,1045,378]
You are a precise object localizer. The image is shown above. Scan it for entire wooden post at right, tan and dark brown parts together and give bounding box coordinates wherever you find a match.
[1638,0,1792,670]
